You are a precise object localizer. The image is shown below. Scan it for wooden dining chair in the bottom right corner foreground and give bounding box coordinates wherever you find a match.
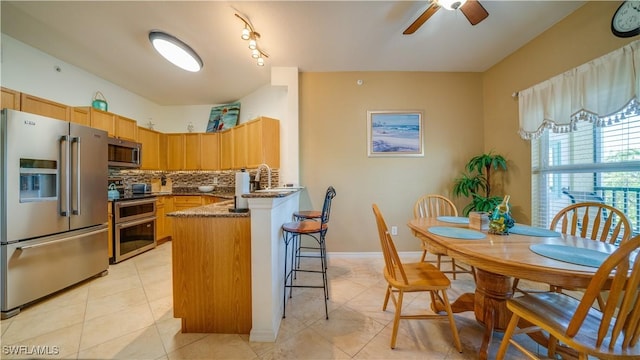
[496,236,640,360]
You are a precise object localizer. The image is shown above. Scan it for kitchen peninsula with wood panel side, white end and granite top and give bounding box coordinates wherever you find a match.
[167,189,300,342]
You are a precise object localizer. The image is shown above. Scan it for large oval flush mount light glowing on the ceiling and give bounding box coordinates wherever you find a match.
[149,30,203,72]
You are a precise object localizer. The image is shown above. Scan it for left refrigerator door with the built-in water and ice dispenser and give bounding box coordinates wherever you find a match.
[0,109,69,243]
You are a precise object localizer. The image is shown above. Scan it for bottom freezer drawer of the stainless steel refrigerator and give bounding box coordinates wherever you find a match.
[0,225,109,317]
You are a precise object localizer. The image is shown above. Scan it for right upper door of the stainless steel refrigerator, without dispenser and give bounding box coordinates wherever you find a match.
[69,123,108,229]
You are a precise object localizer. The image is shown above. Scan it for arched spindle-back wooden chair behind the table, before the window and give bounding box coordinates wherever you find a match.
[513,202,633,304]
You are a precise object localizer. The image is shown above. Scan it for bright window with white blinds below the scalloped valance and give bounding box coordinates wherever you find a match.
[531,100,640,235]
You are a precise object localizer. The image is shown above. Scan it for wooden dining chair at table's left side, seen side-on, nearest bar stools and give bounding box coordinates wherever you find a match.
[373,204,462,352]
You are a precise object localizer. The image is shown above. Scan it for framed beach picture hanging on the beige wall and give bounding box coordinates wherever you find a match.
[367,111,424,157]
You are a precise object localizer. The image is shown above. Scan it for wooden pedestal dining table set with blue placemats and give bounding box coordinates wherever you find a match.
[408,217,616,359]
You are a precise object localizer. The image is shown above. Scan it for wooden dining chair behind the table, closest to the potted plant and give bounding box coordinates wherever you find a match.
[413,194,475,280]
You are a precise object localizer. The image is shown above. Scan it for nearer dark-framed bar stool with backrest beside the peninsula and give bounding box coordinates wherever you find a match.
[282,186,336,319]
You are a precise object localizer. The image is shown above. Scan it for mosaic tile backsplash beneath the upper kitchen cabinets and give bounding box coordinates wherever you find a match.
[109,169,280,189]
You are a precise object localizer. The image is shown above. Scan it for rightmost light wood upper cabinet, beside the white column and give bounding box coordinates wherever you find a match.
[246,117,280,169]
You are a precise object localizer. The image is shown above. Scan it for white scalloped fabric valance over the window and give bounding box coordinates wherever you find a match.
[518,40,640,139]
